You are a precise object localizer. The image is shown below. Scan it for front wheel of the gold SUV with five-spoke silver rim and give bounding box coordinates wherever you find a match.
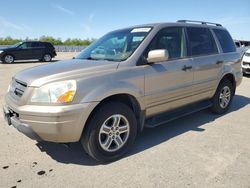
[81,102,137,162]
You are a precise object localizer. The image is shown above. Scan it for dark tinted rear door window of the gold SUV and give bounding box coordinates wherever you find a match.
[187,27,218,56]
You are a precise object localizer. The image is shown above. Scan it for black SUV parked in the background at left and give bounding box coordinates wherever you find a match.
[0,41,56,63]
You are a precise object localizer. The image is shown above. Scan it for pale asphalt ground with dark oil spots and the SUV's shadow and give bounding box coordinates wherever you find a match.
[0,53,250,188]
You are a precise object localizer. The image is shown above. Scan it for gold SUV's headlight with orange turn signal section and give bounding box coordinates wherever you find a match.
[30,80,76,103]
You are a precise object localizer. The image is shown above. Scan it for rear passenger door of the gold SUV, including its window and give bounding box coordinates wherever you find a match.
[186,27,220,101]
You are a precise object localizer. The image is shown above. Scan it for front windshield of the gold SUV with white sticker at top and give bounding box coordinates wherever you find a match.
[76,27,151,61]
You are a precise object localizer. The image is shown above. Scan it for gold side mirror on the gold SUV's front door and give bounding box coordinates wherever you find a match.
[147,49,169,63]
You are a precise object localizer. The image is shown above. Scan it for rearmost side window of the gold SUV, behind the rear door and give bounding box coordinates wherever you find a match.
[213,29,236,53]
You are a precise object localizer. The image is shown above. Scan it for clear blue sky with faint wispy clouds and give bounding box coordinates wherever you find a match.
[0,0,250,40]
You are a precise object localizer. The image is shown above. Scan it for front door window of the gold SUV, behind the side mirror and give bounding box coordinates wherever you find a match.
[145,27,187,59]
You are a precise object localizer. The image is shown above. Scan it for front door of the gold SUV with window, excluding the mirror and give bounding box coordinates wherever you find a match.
[144,27,193,116]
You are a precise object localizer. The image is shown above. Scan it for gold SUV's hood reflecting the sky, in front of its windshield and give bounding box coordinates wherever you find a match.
[15,59,119,87]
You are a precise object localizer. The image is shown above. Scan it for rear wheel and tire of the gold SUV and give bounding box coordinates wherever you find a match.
[211,80,234,114]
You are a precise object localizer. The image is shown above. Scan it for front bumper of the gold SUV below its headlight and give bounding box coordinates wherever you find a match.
[3,97,97,143]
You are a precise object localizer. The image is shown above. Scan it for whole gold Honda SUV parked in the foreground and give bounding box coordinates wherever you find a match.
[3,20,242,162]
